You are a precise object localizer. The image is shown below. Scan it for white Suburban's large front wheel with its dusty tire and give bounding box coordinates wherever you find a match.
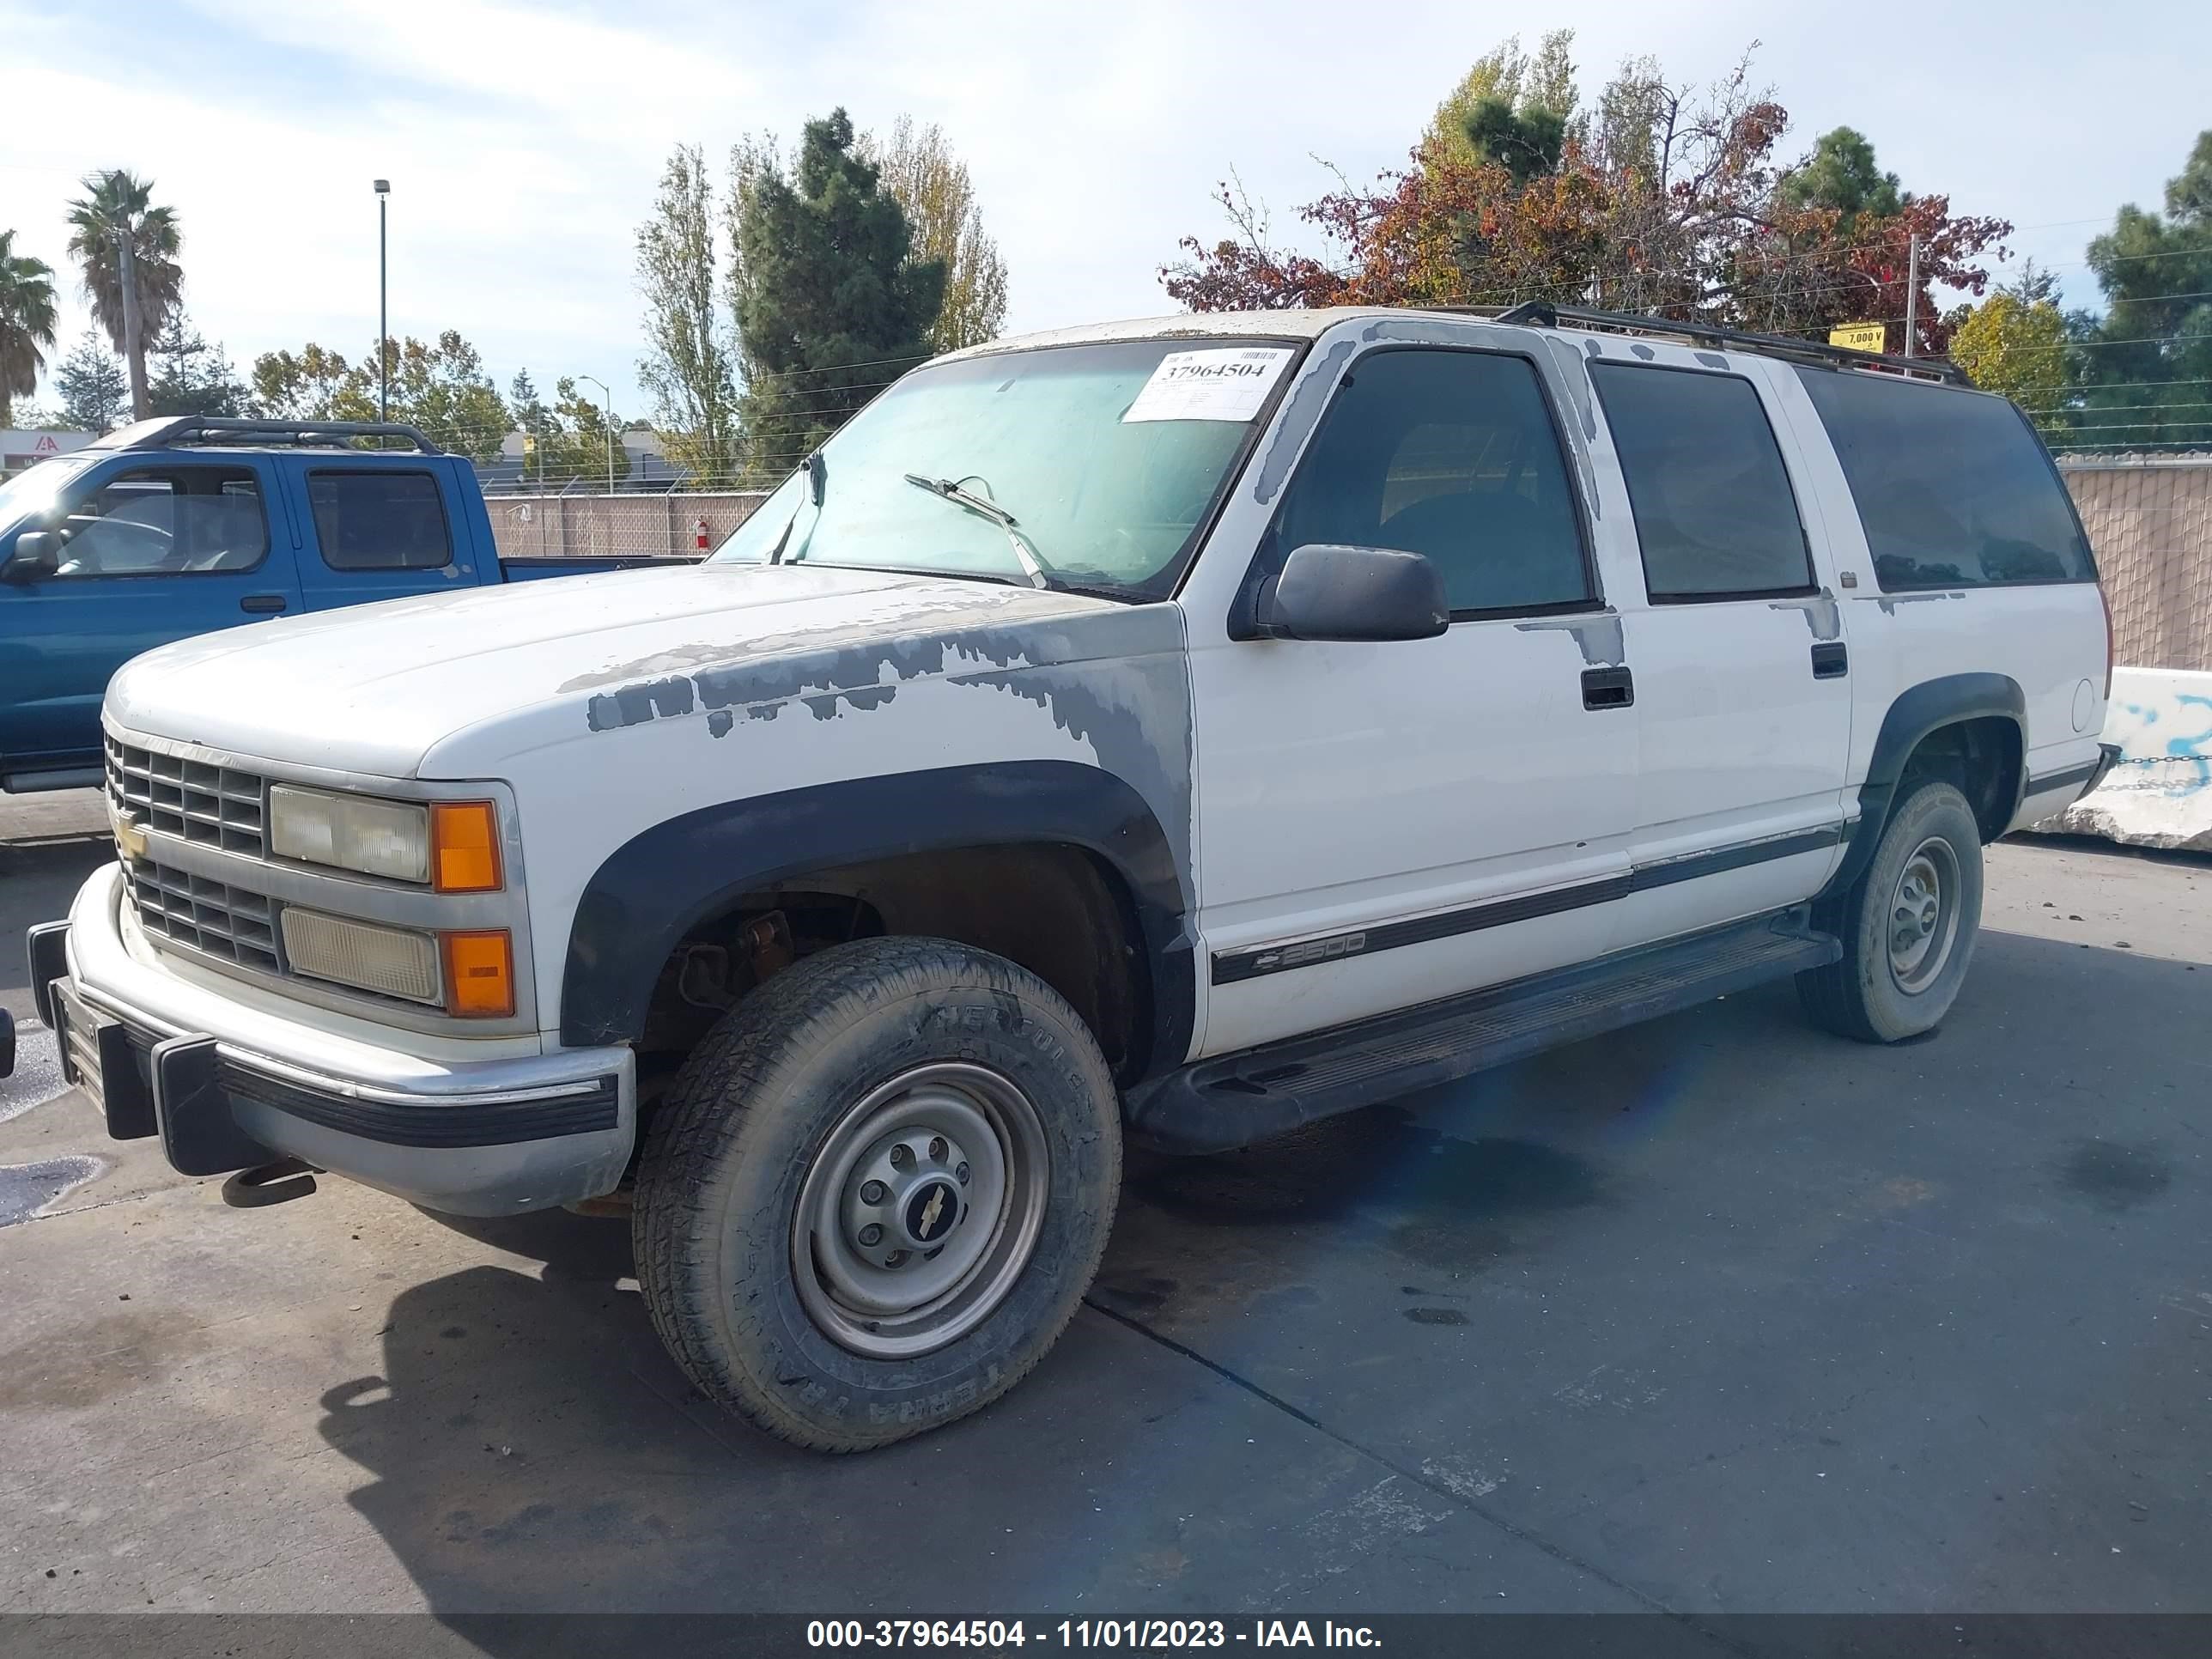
[633,938,1121,1451]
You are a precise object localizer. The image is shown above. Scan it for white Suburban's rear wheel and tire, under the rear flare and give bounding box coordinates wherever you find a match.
[1798,779,1982,1042]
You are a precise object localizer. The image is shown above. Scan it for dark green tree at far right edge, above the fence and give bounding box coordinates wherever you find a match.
[2075,131,2212,449]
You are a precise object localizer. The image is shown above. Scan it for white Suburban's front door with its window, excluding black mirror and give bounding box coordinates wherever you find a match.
[1192,344,1639,1053]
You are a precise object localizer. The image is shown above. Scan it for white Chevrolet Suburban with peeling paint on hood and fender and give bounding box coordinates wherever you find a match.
[17,305,2111,1449]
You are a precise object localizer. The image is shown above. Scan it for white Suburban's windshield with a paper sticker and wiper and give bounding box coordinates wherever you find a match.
[714,341,1297,598]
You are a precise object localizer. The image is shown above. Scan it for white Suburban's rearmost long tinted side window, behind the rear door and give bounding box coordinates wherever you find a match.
[1798,368,2097,591]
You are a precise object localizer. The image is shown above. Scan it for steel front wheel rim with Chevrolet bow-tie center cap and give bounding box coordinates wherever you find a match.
[792,1061,1051,1358]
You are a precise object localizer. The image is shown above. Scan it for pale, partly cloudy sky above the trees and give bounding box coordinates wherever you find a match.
[0,0,2212,416]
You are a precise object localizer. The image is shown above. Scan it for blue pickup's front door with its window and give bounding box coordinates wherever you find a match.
[0,453,301,775]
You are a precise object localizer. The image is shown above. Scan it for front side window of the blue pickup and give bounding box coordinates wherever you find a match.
[55,467,270,580]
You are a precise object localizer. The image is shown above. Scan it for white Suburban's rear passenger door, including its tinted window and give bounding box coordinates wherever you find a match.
[1590,351,1851,947]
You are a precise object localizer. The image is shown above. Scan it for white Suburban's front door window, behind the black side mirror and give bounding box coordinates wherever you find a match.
[1276,352,1593,617]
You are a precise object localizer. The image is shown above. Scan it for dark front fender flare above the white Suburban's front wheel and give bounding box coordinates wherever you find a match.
[560,761,1197,1071]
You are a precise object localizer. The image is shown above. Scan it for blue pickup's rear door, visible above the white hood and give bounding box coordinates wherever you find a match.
[299,456,476,611]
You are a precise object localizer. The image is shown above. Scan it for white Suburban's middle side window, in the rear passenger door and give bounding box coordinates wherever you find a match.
[1590,362,1812,604]
